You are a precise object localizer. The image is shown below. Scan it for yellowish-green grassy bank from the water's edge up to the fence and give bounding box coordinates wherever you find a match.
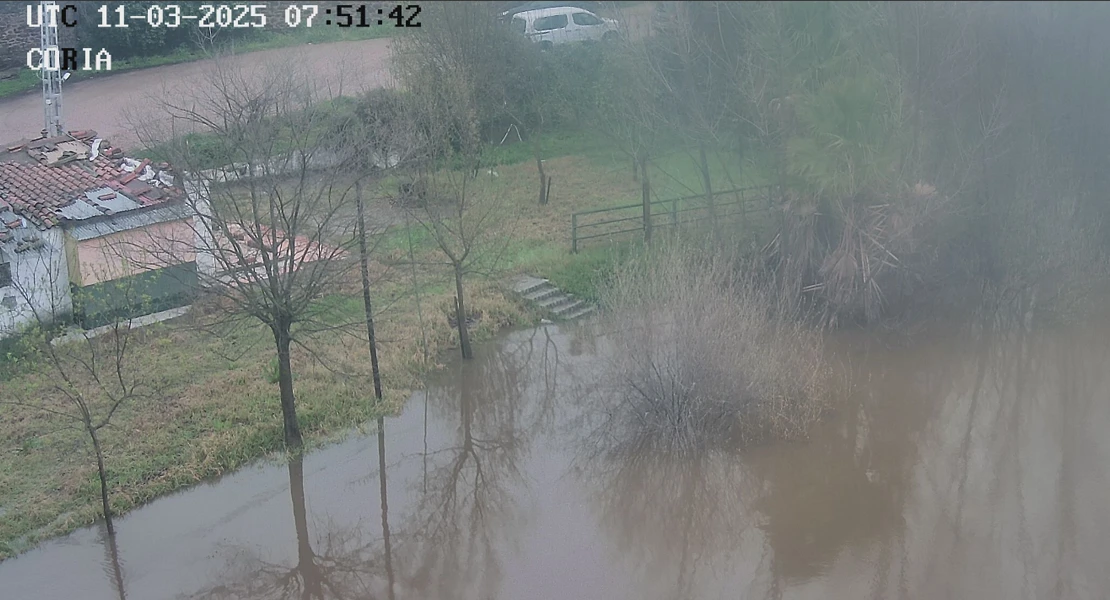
[0,128,763,558]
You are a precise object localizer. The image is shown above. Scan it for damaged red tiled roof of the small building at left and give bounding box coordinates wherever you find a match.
[0,131,184,228]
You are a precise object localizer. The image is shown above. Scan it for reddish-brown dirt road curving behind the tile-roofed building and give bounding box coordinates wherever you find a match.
[0,39,390,149]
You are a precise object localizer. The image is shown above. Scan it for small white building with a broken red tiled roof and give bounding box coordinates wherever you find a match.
[0,131,196,337]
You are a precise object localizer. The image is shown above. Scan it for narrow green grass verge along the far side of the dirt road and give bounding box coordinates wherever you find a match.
[0,27,398,99]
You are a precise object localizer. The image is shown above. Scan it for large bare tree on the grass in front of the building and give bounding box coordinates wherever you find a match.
[139,61,357,449]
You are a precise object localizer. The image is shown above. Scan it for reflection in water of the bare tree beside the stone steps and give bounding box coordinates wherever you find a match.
[396,328,559,598]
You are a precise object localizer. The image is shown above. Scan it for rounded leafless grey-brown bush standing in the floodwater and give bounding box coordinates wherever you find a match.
[603,234,830,451]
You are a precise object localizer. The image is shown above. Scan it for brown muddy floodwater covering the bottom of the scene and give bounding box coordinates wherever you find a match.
[0,314,1110,600]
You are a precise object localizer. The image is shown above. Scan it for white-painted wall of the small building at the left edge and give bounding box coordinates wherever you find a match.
[0,227,73,337]
